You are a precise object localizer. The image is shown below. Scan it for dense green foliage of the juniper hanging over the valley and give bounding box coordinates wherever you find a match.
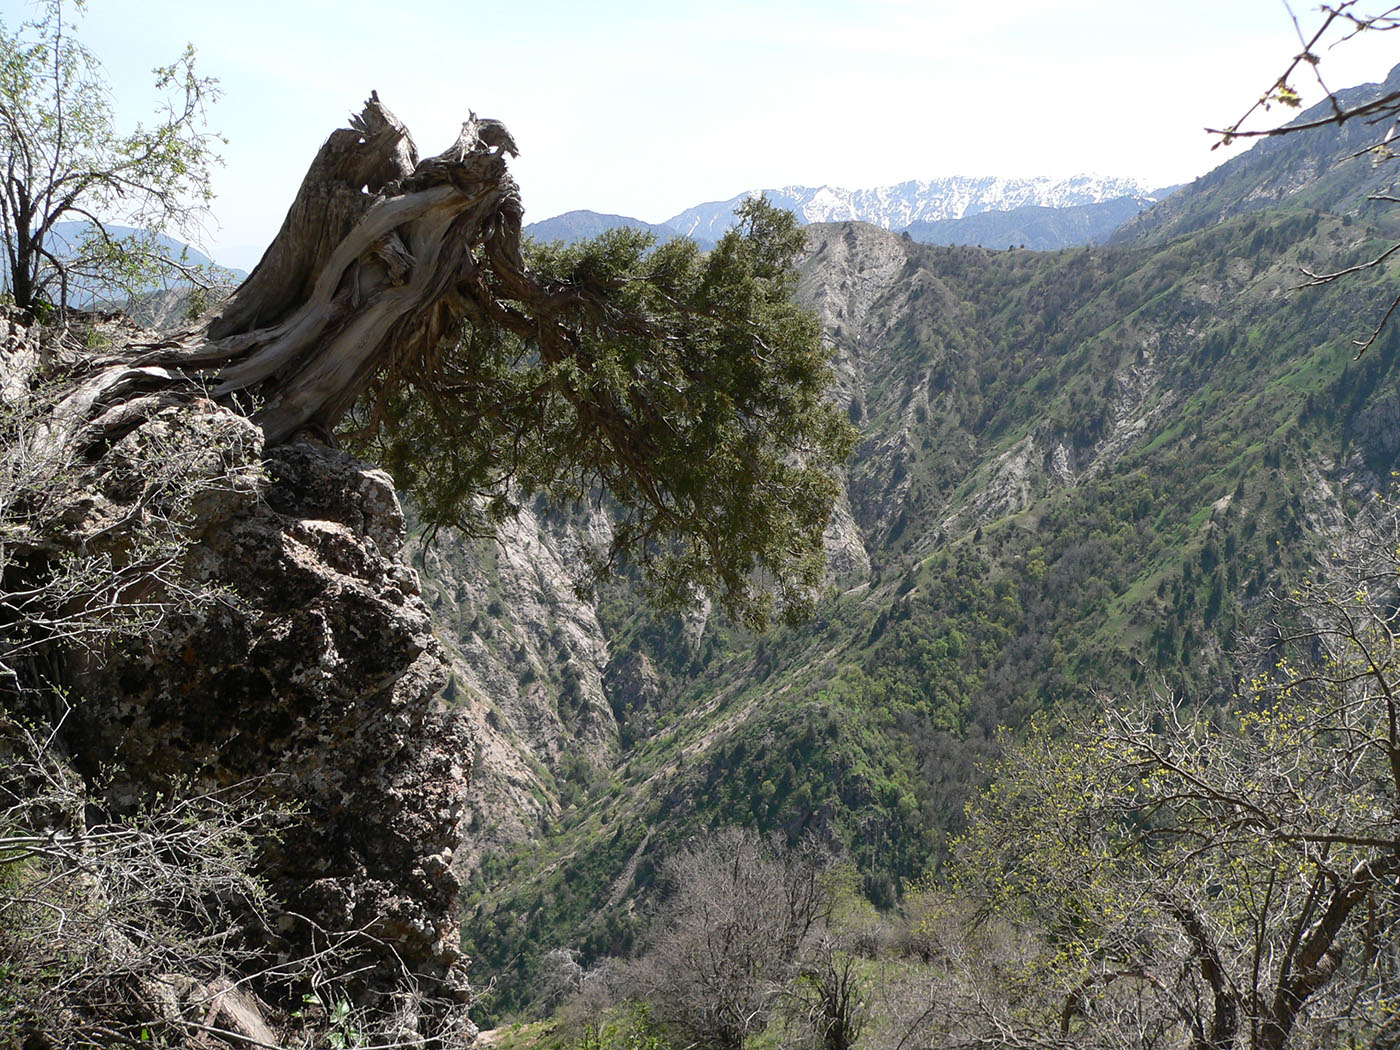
[354,199,854,626]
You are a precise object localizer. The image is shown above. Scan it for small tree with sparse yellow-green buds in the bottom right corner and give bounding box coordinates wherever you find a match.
[944,520,1400,1050]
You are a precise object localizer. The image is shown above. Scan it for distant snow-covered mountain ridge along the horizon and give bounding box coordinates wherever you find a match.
[666,175,1151,239]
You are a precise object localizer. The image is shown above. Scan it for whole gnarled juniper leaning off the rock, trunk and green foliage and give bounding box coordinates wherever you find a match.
[11,90,851,624]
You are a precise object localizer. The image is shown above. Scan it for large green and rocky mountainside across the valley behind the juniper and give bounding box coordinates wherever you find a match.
[445,59,1400,1021]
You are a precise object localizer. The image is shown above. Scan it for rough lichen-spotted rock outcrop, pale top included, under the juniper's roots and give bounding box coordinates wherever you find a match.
[6,312,473,1044]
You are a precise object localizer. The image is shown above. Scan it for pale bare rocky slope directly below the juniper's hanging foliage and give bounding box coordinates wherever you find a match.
[417,503,620,871]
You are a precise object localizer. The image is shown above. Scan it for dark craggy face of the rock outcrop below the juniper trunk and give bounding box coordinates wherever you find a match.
[58,425,472,1036]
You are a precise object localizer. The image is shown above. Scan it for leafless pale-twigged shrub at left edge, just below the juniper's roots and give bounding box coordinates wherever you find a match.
[0,333,262,687]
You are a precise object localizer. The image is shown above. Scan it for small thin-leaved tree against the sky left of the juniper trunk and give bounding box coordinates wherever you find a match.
[0,0,218,309]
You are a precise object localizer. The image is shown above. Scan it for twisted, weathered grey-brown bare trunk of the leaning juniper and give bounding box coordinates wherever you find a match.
[43,95,532,456]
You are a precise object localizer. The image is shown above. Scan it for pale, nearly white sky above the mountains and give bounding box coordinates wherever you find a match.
[0,0,1400,267]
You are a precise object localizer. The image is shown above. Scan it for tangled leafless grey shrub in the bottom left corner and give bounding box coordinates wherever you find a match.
[0,718,289,1047]
